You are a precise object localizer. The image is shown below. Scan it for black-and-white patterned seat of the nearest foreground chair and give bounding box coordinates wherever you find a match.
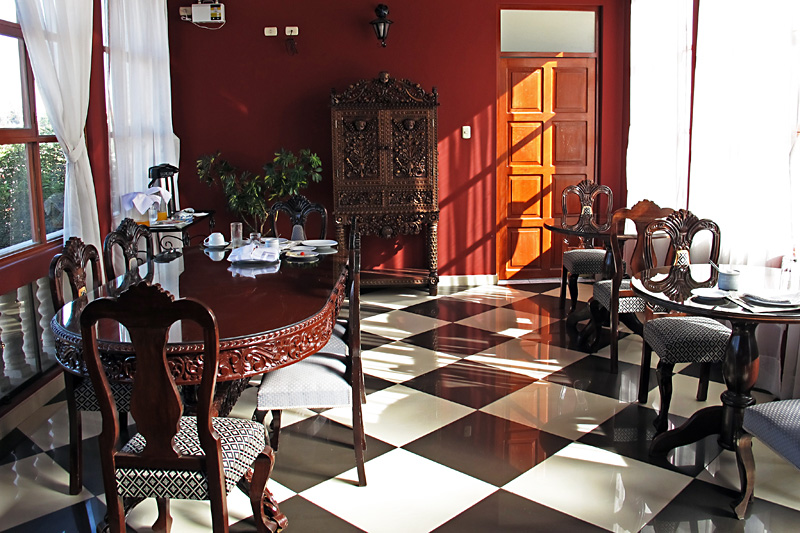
[117,416,266,500]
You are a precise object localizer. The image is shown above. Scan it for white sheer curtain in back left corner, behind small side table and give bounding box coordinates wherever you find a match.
[106,0,179,225]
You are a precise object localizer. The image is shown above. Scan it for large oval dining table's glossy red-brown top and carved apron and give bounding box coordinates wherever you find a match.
[51,246,347,416]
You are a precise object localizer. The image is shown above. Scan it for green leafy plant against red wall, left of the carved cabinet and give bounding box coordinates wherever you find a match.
[197,148,322,234]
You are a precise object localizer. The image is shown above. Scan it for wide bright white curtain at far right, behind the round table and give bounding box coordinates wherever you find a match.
[689,0,800,397]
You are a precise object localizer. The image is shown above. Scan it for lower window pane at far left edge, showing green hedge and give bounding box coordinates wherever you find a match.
[0,140,33,250]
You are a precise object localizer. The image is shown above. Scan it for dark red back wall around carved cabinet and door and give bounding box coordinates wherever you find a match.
[167,0,628,275]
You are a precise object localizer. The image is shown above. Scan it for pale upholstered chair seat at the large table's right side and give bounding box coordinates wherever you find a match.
[257,335,352,411]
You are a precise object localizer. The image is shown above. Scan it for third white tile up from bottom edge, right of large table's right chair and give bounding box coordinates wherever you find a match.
[361,341,459,383]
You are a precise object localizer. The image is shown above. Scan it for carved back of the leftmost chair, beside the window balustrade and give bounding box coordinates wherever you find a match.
[49,237,100,311]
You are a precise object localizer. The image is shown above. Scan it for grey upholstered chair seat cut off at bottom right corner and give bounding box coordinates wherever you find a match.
[743,399,800,468]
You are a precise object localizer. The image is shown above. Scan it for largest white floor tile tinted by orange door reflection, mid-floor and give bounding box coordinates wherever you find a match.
[481,381,628,440]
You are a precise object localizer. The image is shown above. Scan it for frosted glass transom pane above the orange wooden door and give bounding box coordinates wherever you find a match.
[500,9,595,53]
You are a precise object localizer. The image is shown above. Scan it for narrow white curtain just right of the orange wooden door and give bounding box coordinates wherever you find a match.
[627,0,692,209]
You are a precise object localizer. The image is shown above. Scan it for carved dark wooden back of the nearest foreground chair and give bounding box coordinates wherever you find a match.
[80,281,227,530]
